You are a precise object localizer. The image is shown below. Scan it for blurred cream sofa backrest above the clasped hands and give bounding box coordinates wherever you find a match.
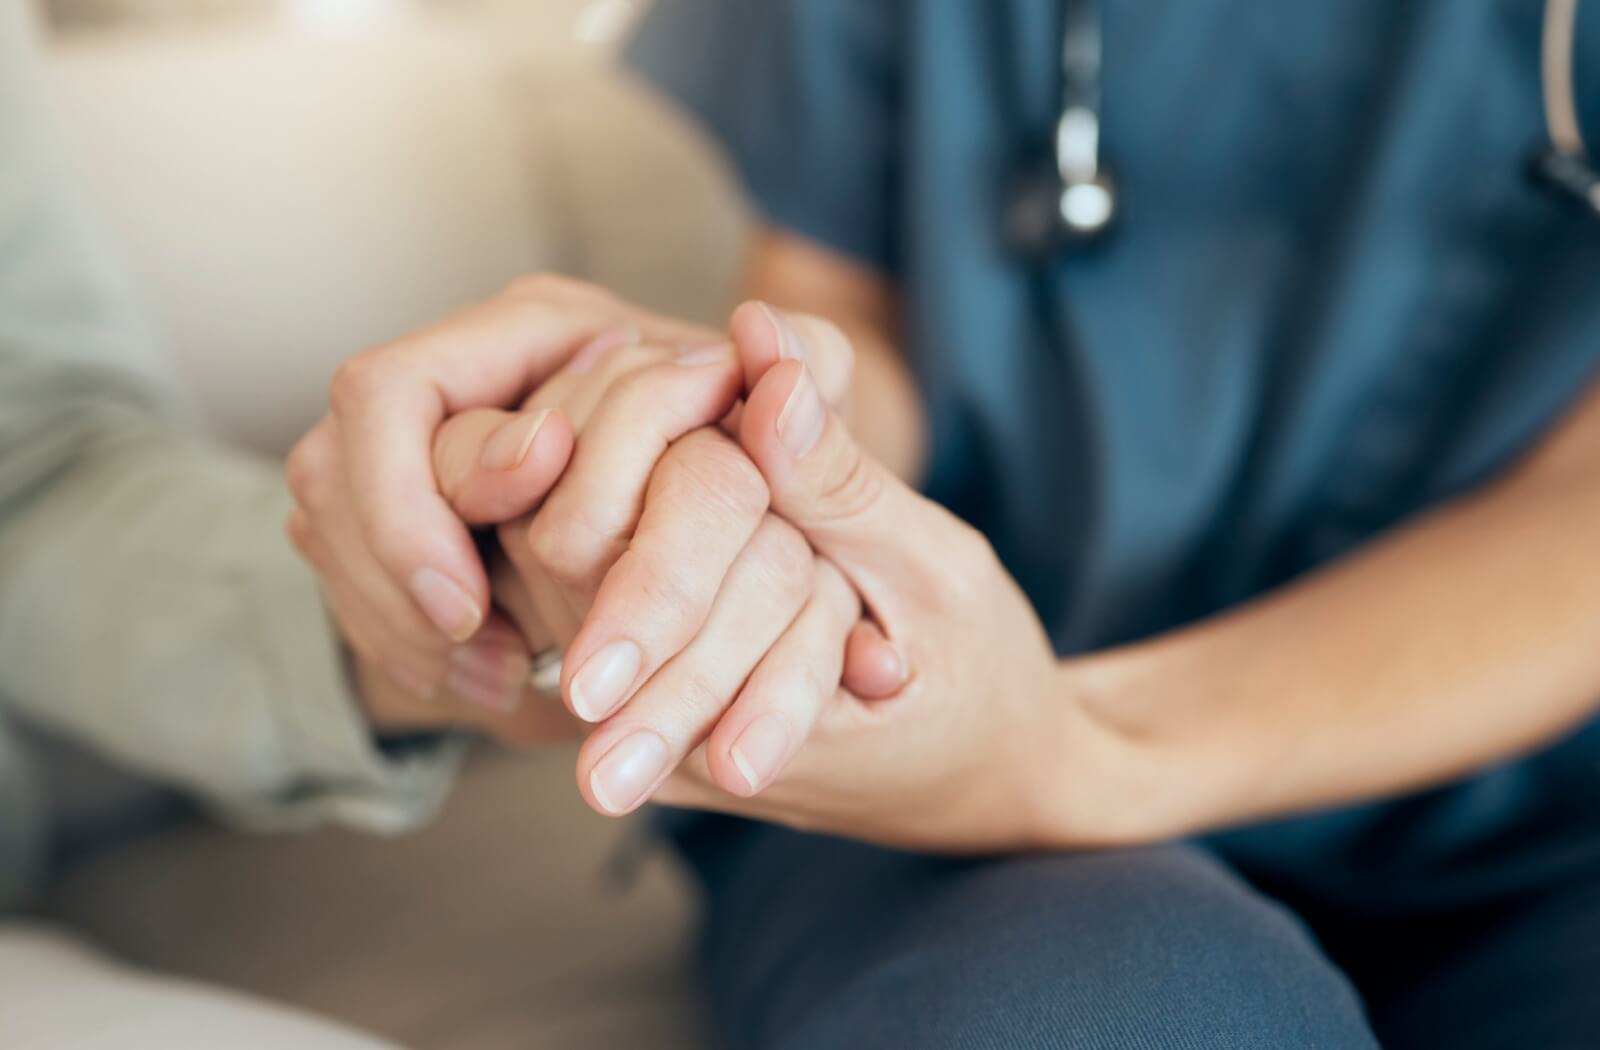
[31,0,742,451]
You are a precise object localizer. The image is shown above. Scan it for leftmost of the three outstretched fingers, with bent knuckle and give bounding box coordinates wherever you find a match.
[556,427,766,722]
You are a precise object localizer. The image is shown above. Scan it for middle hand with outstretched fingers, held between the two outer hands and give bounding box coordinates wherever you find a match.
[437,312,899,813]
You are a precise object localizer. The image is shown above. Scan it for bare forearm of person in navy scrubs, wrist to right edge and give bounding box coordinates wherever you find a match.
[1066,380,1600,837]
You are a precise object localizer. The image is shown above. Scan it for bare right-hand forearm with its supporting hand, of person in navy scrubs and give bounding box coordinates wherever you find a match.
[630,227,1600,852]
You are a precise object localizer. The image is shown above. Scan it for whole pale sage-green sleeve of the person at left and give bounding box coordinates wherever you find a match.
[0,2,458,831]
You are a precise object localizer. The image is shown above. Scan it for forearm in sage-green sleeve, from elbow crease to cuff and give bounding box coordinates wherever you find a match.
[0,388,453,829]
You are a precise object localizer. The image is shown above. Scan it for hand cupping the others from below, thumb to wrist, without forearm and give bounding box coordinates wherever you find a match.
[659,336,1131,852]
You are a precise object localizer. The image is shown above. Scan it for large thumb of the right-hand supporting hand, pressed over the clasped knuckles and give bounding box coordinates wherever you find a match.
[739,362,987,624]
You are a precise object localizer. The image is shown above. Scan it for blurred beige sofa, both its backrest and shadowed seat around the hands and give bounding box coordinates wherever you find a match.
[31,0,746,1050]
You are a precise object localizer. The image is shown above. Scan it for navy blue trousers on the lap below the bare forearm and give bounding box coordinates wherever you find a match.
[678,717,1600,1050]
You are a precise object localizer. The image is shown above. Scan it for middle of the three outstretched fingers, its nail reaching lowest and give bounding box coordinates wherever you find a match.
[578,517,813,816]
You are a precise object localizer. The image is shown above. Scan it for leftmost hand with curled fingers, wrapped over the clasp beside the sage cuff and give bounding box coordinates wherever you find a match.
[286,277,709,735]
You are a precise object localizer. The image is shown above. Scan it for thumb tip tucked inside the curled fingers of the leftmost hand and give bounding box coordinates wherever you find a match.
[434,408,573,525]
